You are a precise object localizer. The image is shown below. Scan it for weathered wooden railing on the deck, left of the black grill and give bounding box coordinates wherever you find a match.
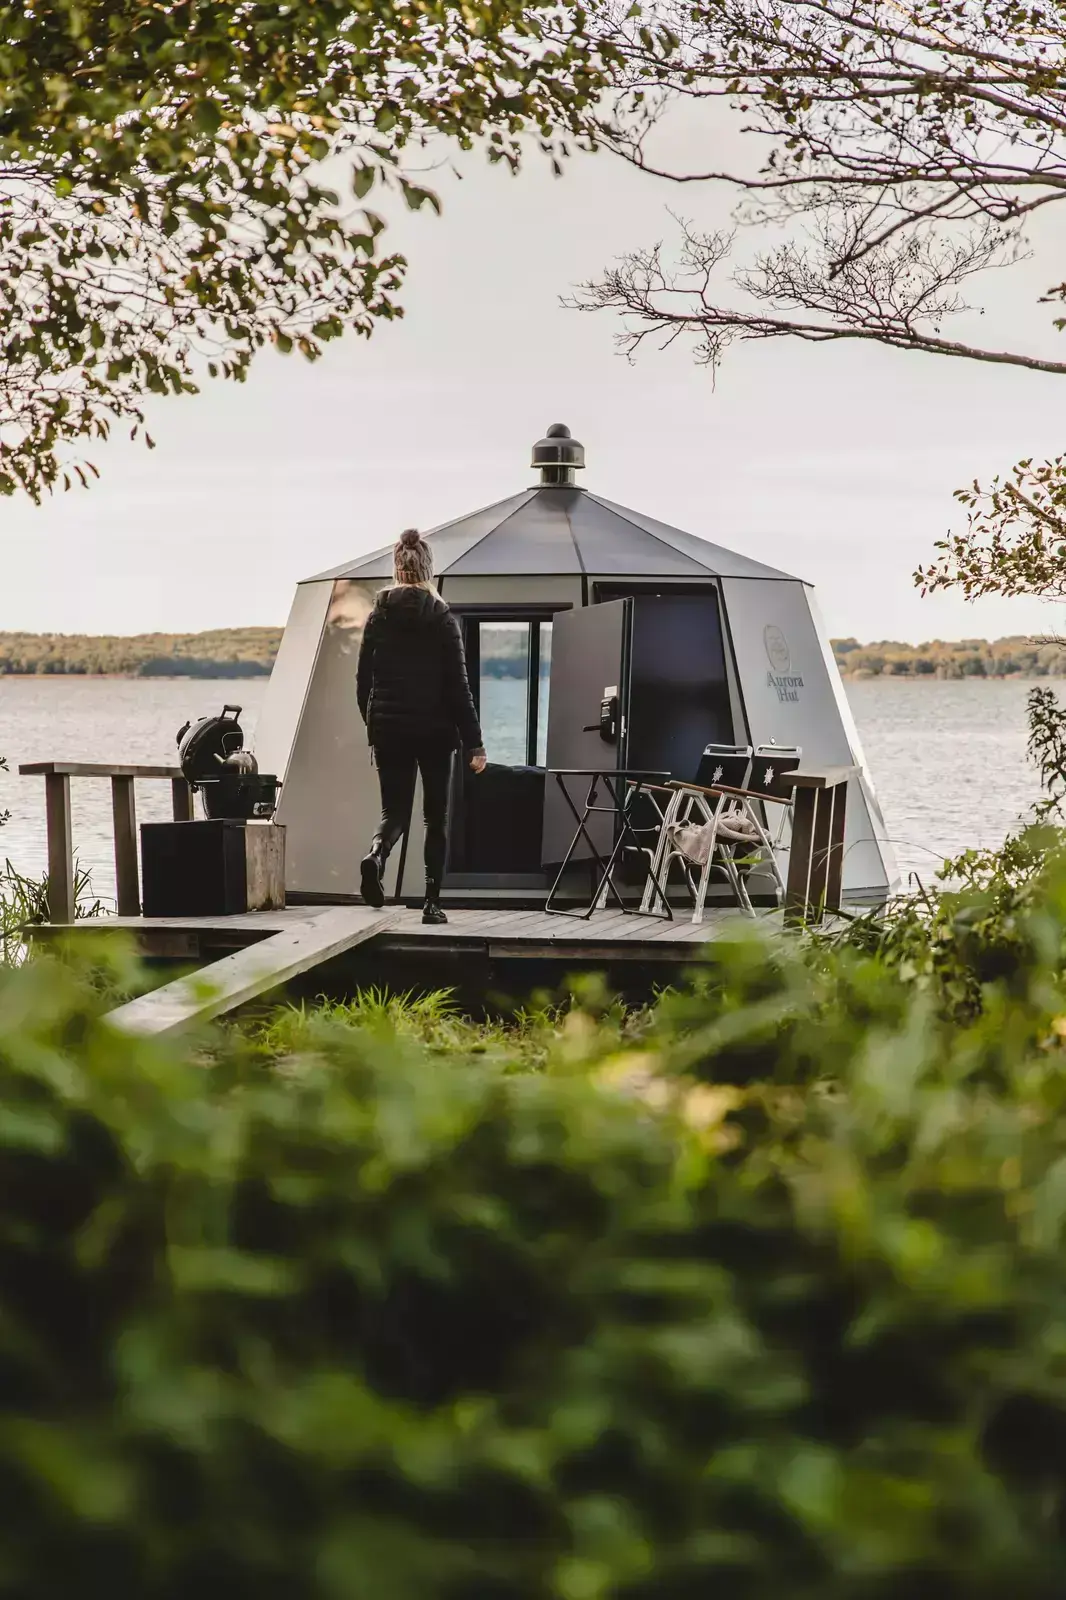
[19,762,192,923]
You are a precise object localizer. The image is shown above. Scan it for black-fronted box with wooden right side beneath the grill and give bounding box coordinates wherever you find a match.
[141,818,285,917]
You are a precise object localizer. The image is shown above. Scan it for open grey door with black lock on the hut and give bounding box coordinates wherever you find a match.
[543,600,632,867]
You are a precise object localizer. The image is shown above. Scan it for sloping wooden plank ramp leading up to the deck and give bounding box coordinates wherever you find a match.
[107,906,395,1034]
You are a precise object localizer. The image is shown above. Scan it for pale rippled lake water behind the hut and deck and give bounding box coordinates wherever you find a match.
[0,677,1047,898]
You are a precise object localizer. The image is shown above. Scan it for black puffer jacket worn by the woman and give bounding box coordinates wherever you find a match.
[357,584,482,750]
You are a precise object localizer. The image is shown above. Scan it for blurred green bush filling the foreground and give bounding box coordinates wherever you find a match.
[0,902,1066,1600]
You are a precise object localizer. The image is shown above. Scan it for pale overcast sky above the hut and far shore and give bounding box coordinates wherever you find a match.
[0,112,1066,642]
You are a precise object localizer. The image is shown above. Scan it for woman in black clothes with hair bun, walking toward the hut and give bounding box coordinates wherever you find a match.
[357,528,485,923]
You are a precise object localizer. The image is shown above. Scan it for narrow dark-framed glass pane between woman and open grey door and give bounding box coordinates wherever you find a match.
[466,618,552,766]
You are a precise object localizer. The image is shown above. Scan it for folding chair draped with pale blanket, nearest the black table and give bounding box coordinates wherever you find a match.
[640,744,752,922]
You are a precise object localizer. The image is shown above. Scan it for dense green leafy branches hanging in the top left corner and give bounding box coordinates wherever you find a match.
[0,0,602,498]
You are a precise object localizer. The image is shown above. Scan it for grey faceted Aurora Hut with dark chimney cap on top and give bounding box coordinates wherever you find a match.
[256,424,896,904]
